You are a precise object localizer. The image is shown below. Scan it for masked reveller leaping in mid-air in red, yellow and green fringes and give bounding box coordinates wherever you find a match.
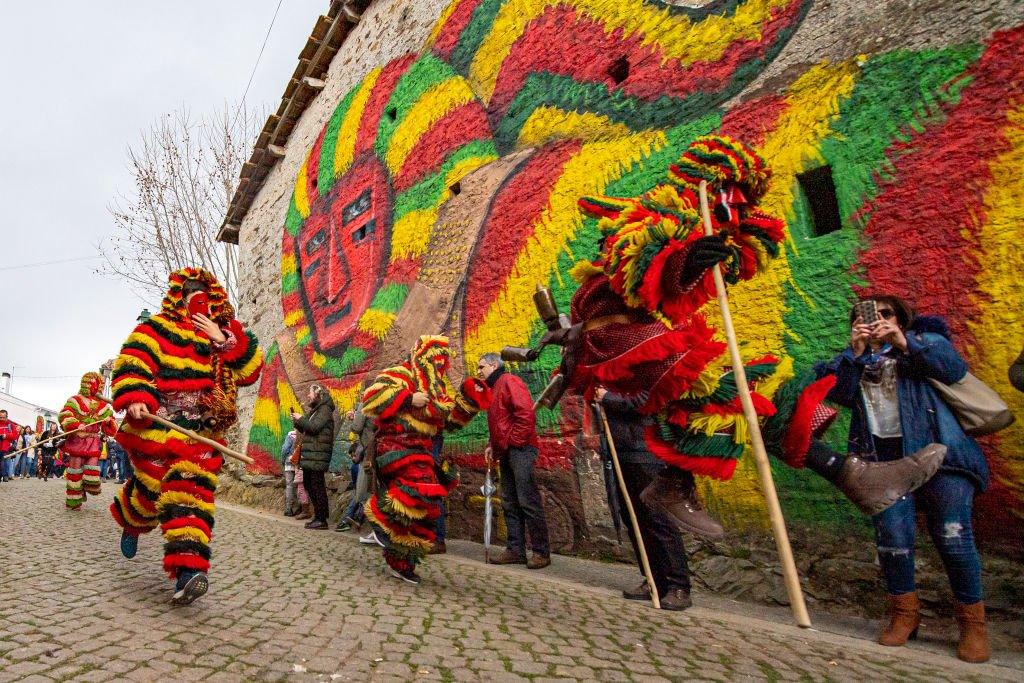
[561,135,944,536]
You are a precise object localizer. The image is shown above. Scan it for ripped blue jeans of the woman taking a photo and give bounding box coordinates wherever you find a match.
[872,472,982,605]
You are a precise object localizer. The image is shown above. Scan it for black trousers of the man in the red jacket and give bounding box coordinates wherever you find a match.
[498,445,551,557]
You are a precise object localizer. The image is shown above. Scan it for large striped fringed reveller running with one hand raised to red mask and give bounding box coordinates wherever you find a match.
[111,268,263,604]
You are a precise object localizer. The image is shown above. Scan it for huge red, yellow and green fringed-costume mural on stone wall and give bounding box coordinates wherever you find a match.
[249,0,1024,552]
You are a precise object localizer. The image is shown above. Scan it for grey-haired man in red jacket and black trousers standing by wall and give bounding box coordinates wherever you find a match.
[476,353,551,569]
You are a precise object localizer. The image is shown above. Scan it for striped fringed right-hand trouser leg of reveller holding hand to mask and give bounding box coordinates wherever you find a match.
[157,456,223,579]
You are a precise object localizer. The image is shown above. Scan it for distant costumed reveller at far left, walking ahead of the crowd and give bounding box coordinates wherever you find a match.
[57,372,118,510]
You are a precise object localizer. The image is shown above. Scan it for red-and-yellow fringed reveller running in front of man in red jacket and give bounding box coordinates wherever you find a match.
[362,336,490,584]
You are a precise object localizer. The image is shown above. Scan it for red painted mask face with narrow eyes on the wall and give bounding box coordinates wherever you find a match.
[294,157,391,353]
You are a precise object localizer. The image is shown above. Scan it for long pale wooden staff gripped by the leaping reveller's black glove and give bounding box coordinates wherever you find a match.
[699,180,811,629]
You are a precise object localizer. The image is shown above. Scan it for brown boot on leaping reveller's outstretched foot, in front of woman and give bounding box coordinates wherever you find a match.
[836,443,946,516]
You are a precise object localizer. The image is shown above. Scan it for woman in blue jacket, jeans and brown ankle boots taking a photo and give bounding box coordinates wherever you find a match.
[823,296,989,661]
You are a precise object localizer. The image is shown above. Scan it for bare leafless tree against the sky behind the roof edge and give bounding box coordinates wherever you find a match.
[97,102,265,301]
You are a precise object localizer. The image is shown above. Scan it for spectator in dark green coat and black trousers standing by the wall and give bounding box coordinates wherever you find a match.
[292,384,334,530]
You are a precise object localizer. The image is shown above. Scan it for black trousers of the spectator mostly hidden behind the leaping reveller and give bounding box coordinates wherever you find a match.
[615,462,690,596]
